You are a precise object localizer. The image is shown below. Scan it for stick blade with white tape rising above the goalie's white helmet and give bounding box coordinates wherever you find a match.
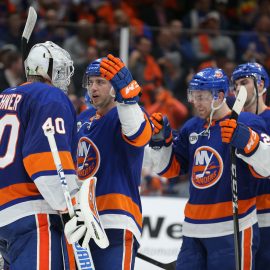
[21,7,37,66]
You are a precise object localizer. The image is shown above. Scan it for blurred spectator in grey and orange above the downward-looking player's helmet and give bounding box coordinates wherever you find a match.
[192,11,235,61]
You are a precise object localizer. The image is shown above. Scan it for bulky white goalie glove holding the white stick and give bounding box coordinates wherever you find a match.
[65,177,109,248]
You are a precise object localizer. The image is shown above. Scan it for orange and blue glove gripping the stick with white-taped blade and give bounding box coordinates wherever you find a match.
[220,119,260,156]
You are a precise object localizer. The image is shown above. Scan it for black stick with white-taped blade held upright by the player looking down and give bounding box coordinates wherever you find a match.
[230,86,247,270]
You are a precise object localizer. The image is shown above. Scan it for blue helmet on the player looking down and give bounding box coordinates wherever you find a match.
[188,68,229,101]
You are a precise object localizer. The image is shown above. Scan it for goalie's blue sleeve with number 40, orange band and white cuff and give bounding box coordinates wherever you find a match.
[22,95,78,210]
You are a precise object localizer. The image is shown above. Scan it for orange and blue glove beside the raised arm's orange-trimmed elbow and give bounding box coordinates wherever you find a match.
[149,113,173,149]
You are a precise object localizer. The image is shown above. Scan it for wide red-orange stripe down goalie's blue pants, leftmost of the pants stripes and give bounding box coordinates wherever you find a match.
[37,214,50,270]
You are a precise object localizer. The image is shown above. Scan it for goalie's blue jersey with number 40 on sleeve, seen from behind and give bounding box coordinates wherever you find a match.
[0,83,77,226]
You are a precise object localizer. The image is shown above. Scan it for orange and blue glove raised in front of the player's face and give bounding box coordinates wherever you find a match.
[100,54,141,104]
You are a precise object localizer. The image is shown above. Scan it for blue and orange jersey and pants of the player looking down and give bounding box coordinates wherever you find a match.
[149,110,265,270]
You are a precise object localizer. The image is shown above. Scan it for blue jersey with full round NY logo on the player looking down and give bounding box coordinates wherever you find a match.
[160,113,265,238]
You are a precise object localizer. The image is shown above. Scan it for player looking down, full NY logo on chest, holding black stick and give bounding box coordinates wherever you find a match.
[147,68,264,270]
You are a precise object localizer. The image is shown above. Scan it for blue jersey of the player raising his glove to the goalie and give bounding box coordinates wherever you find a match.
[77,107,152,241]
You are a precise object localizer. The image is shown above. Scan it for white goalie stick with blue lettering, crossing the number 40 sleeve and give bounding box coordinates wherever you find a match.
[43,126,95,270]
